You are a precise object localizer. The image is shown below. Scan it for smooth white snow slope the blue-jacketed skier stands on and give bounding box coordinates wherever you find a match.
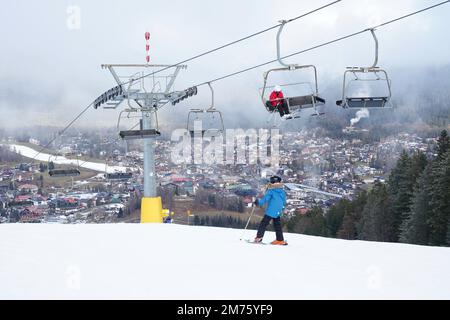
[0,224,450,299]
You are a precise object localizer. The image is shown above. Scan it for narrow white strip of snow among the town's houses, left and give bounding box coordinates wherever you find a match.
[6,144,127,173]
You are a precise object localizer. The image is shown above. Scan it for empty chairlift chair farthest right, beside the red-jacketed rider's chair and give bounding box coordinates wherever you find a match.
[336,29,392,109]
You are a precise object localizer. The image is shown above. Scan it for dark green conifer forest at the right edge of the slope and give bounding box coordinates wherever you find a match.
[285,130,450,246]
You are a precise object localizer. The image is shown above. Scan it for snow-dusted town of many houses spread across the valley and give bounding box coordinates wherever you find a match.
[0,131,436,227]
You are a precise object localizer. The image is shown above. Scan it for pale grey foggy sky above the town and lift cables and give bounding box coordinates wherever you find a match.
[0,0,450,127]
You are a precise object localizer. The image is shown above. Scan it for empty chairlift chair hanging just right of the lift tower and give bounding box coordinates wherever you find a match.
[186,82,225,137]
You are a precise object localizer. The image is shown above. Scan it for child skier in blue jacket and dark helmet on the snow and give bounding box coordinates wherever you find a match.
[254,176,287,245]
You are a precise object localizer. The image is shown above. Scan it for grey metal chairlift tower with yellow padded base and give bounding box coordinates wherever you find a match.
[94,33,197,223]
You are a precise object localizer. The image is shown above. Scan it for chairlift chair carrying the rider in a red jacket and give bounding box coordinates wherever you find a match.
[260,20,325,119]
